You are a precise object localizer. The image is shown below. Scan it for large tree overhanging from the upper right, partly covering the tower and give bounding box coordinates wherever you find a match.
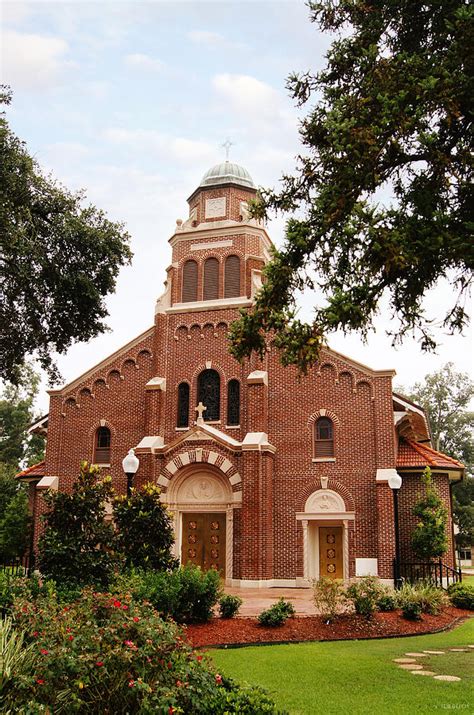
[231,0,474,372]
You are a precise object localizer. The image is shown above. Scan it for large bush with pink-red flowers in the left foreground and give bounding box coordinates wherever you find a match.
[7,589,275,715]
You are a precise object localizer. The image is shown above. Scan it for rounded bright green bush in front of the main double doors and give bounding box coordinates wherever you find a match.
[134,565,222,623]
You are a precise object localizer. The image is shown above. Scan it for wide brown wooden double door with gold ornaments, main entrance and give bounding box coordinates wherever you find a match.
[181,512,226,577]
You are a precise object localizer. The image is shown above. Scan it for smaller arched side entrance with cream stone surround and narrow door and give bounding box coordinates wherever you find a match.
[296,489,354,582]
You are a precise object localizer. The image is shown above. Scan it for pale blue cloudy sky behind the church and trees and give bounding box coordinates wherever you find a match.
[0,0,474,411]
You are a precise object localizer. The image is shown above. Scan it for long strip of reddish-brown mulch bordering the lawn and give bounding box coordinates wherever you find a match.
[186,607,472,648]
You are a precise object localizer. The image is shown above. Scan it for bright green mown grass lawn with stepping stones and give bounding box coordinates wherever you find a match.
[211,619,474,715]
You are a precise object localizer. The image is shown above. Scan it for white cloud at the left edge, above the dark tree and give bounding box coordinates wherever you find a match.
[2,30,75,89]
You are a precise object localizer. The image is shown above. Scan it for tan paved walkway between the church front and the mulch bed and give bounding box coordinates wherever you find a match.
[225,587,317,617]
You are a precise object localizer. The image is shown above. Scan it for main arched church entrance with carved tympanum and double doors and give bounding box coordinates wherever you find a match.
[163,464,236,582]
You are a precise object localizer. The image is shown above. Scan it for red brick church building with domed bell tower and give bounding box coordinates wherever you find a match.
[18,161,463,586]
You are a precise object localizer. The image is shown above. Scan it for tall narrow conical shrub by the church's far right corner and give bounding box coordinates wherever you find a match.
[411,467,448,560]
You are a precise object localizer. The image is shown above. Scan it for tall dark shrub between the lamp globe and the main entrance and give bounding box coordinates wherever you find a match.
[114,483,177,571]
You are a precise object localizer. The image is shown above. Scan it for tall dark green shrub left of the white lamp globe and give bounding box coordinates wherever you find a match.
[38,462,115,588]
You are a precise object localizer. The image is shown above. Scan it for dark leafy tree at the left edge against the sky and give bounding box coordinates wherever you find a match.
[0,86,131,383]
